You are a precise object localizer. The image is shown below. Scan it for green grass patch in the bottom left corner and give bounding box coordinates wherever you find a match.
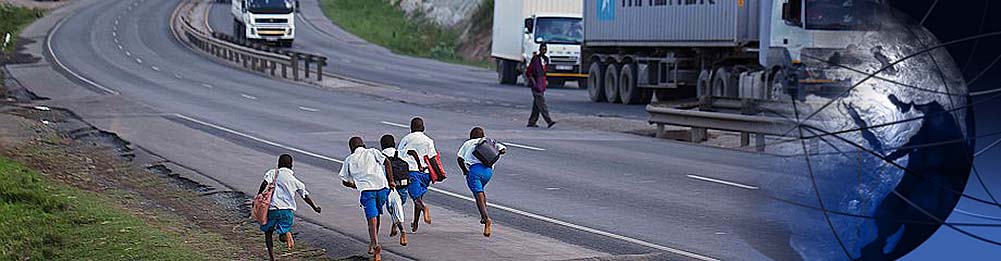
[0,158,210,260]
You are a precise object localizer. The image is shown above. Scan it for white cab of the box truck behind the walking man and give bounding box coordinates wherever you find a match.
[520,13,587,87]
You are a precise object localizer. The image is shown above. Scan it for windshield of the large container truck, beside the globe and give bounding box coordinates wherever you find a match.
[806,0,879,30]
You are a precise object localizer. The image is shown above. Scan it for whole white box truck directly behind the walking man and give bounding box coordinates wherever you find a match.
[490,0,588,88]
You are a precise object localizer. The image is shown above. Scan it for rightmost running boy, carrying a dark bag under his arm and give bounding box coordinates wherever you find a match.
[457,127,508,237]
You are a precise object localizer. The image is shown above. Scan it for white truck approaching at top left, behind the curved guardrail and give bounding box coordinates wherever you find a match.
[230,0,298,47]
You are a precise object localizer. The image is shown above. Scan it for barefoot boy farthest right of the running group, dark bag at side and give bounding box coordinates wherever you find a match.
[456,127,508,237]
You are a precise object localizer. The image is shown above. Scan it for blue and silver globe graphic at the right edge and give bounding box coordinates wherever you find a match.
[762,3,973,260]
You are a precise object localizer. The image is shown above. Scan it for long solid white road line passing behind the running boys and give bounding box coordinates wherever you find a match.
[174,114,719,261]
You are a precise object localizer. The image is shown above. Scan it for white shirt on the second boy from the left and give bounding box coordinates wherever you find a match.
[340,148,389,191]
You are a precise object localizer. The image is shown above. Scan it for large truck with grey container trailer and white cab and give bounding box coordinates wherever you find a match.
[582,0,878,104]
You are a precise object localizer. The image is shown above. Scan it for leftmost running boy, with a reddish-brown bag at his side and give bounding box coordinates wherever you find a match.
[257,154,320,260]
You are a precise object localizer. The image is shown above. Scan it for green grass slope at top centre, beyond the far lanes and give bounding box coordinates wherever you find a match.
[320,0,492,67]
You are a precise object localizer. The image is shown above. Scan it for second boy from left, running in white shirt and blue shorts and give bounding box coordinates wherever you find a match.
[339,137,395,260]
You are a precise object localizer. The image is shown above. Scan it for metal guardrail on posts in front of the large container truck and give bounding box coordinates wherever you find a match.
[647,98,798,151]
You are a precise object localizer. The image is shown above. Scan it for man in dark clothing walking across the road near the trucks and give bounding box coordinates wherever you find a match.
[525,43,557,128]
